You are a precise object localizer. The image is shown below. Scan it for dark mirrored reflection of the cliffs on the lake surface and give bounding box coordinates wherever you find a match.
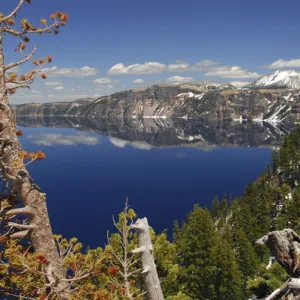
[17,116,288,148]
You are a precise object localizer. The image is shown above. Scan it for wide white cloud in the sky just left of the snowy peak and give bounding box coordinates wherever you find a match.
[204,66,261,78]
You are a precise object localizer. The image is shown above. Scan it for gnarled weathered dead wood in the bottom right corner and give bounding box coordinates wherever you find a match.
[256,229,300,300]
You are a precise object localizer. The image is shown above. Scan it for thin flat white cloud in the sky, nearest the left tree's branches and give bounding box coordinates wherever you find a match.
[43,66,99,77]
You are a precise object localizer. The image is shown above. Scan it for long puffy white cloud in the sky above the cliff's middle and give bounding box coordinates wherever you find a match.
[107,62,166,75]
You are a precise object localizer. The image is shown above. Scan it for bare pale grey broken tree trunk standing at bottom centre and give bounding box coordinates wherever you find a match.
[131,218,164,300]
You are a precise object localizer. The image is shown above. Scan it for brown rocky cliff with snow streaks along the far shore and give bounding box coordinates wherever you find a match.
[15,84,300,122]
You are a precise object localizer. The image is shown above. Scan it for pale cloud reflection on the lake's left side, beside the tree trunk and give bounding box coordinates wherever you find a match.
[27,133,100,146]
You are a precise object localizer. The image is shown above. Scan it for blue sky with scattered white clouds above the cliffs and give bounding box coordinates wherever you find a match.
[1,0,300,103]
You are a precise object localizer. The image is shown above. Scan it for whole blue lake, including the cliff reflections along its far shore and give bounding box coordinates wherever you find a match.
[17,117,285,247]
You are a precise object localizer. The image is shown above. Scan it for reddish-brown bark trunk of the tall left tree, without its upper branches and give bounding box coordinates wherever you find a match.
[0,31,68,299]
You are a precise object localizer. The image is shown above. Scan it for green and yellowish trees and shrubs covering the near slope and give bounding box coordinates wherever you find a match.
[0,128,300,300]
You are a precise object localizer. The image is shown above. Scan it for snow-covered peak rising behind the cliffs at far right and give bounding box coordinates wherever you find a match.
[247,70,300,89]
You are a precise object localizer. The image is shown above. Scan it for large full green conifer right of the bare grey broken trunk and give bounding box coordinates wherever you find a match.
[175,205,219,300]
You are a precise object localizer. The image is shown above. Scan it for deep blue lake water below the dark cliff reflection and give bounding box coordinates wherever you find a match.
[17,127,271,247]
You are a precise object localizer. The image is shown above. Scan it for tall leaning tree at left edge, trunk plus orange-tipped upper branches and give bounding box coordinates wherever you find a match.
[0,0,68,298]
